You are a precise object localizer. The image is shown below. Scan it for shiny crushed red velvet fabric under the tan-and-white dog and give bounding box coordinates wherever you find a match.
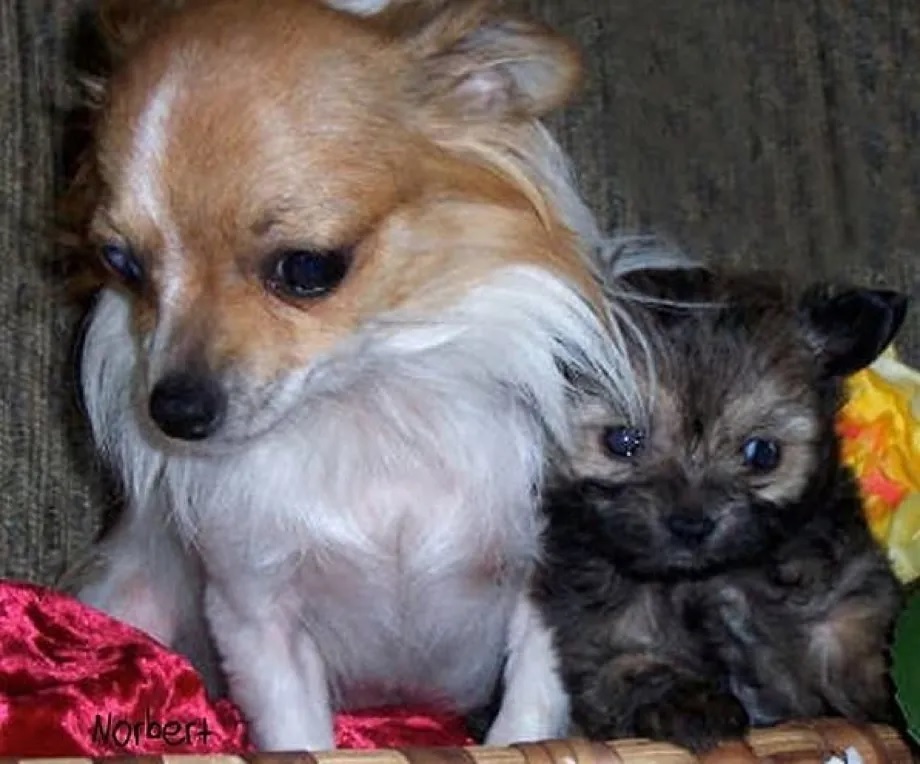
[0,582,473,757]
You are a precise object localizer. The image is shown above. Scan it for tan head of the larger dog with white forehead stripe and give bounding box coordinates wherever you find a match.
[75,0,608,448]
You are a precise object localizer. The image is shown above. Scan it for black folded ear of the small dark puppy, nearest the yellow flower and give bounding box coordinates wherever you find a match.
[800,284,908,377]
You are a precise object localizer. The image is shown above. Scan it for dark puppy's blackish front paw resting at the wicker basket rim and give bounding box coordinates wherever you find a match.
[635,682,749,753]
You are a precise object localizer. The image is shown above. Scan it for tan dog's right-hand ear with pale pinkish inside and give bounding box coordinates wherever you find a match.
[396,0,582,122]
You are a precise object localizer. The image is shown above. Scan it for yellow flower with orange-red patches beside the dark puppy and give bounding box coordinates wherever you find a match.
[838,350,920,581]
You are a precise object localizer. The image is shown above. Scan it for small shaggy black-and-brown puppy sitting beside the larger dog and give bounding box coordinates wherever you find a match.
[538,270,906,750]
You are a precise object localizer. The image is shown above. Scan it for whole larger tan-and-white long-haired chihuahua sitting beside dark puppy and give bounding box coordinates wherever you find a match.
[63,0,668,750]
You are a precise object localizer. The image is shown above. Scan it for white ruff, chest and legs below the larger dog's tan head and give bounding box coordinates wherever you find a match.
[75,260,644,749]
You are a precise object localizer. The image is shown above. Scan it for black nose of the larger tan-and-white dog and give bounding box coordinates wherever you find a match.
[150,373,227,440]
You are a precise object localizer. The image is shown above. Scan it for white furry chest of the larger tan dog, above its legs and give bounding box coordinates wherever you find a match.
[163,350,541,709]
